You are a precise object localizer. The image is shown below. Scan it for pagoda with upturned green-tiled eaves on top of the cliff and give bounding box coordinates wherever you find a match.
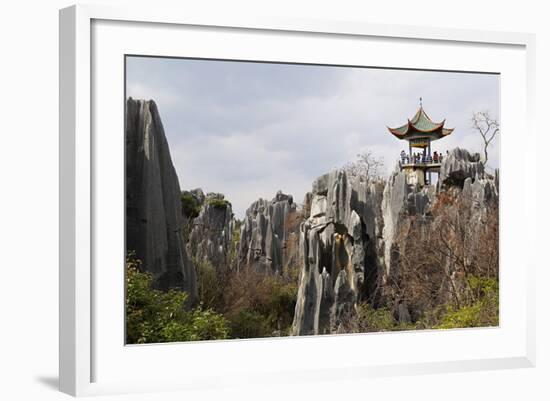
[387,98,454,186]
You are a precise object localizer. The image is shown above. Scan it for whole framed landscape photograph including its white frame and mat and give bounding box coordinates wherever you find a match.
[60,6,536,395]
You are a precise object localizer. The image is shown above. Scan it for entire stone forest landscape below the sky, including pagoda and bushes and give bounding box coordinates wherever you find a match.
[125,98,499,344]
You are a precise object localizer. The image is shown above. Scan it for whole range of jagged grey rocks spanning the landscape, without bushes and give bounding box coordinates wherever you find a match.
[125,98,499,335]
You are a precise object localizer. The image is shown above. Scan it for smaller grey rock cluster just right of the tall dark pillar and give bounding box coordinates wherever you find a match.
[187,189,235,268]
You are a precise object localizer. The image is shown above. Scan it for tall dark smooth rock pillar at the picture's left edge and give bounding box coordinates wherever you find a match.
[125,98,196,300]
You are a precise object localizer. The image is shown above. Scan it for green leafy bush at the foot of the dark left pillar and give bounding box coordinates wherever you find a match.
[126,253,229,344]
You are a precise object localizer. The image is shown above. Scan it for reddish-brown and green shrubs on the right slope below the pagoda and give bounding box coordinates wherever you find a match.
[385,188,499,328]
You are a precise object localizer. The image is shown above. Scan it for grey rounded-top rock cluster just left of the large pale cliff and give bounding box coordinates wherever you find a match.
[237,191,301,273]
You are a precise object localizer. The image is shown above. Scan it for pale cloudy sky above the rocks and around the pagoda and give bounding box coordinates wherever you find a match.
[126,56,500,218]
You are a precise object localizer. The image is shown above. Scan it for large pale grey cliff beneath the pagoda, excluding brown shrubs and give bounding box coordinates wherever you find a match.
[293,149,498,335]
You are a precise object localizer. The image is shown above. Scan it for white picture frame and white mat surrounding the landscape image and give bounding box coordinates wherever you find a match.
[59,5,536,396]
